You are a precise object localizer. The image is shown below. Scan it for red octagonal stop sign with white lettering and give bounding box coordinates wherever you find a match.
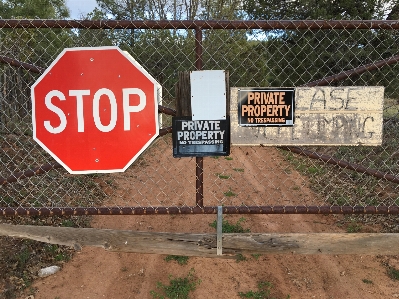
[31,47,161,173]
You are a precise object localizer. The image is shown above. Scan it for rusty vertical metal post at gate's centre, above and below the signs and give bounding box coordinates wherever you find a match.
[195,27,204,207]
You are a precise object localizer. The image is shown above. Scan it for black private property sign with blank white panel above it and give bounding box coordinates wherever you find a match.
[172,70,230,157]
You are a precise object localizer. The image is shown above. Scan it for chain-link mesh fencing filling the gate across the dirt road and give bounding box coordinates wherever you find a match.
[0,20,399,215]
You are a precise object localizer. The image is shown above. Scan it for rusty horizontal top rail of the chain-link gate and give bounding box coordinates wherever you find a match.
[0,19,399,30]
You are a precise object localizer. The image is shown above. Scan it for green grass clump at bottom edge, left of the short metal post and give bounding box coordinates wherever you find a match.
[150,269,201,299]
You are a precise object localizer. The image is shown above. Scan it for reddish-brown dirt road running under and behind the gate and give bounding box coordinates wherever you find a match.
[24,141,399,299]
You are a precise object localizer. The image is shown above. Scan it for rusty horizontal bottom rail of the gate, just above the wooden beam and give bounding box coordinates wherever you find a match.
[0,205,399,216]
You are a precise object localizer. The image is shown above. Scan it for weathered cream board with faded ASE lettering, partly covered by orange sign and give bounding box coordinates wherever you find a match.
[230,86,384,146]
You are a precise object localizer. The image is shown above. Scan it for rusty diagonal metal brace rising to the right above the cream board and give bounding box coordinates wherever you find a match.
[302,55,399,87]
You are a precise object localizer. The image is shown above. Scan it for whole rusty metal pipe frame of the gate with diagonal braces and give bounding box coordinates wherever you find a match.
[0,20,399,216]
